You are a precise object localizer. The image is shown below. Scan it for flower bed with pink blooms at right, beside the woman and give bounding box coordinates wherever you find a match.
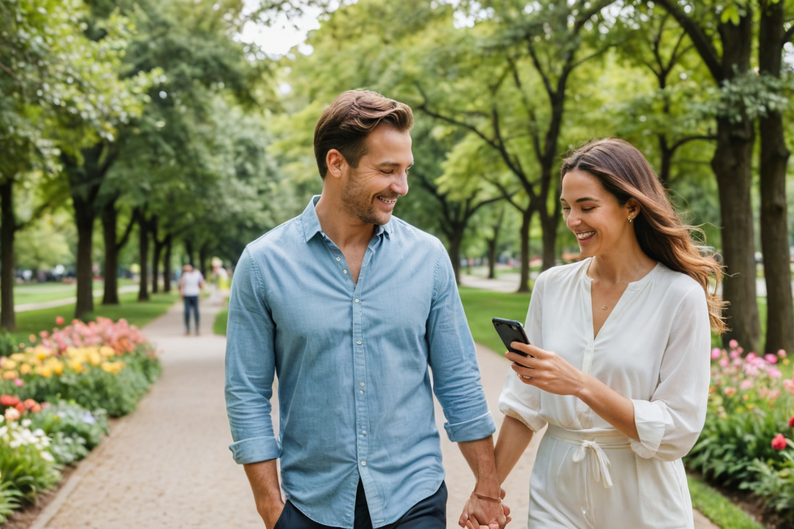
[687,340,794,520]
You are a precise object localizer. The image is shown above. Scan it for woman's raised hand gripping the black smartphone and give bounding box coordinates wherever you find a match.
[505,342,589,396]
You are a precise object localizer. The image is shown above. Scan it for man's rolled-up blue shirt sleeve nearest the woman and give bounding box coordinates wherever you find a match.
[427,242,496,443]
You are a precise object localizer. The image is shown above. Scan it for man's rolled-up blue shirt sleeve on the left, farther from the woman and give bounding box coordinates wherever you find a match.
[226,249,280,464]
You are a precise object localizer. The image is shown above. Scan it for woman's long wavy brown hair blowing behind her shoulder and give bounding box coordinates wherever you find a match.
[560,138,727,334]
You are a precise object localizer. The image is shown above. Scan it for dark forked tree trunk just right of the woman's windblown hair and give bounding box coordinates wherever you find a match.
[655,0,761,350]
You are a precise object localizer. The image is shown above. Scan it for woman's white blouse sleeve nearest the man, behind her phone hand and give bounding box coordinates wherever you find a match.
[499,274,546,432]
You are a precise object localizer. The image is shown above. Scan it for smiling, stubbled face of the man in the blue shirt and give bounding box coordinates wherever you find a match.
[342,124,414,225]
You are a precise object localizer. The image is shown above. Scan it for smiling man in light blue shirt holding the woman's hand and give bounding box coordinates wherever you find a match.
[226,90,509,529]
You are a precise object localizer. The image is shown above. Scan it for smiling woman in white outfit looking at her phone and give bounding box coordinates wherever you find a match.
[496,139,725,529]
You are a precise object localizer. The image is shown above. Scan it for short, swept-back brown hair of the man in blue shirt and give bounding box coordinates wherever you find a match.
[314,90,414,178]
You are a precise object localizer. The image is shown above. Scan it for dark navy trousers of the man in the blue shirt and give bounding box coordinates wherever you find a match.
[273,481,447,529]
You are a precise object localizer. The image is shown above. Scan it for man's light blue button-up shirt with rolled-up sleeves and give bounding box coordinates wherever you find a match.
[226,197,495,528]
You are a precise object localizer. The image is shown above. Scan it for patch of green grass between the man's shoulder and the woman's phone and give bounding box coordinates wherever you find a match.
[459,287,531,353]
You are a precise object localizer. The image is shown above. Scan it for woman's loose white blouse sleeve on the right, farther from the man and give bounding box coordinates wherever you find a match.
[631,285,711,461]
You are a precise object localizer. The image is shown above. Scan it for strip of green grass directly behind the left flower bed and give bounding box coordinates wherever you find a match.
[7,291,179,342]
